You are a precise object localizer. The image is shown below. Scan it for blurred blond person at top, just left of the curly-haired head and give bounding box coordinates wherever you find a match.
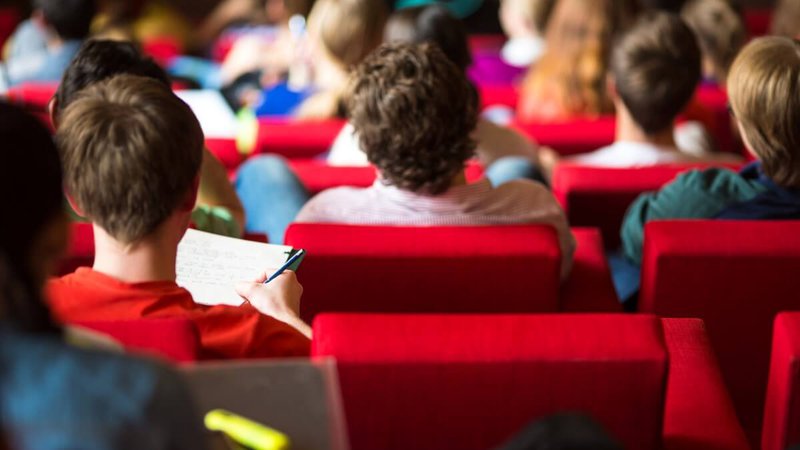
[295,0,388,120]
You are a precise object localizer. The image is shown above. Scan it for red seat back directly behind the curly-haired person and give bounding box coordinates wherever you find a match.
[286,224,561,322]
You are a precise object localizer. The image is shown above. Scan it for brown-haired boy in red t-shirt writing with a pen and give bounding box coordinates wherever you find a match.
[44,75,311,358]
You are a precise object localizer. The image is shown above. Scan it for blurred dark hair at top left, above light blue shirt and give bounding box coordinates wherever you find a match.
[34,0,97,40]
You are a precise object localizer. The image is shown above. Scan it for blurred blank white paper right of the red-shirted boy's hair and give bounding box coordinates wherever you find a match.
[175,89,237,139]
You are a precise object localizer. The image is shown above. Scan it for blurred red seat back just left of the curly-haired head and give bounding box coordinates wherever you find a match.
[254,119,345,159]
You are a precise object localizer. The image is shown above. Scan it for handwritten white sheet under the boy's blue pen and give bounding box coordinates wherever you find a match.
[177,229,292,306]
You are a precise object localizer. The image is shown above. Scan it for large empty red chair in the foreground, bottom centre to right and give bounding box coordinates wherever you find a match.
[312,314,747,450]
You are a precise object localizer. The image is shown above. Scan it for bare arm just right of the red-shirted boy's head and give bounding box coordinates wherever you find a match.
[197,149,245,234]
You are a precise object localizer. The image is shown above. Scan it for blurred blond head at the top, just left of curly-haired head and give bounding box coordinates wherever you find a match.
[308,0,388,68]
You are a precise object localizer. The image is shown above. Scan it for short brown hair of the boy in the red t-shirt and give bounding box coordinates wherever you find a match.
[56,75,203,243]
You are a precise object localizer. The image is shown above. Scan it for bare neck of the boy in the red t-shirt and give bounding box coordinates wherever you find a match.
[93,223,185,283]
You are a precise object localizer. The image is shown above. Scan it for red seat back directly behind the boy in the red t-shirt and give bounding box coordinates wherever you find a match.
[75,319,200,362]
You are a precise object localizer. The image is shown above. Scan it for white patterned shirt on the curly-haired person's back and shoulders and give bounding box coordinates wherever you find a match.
[295,179,575,278]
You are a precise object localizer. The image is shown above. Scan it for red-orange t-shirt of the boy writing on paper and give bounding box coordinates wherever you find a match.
[47,267,310,359]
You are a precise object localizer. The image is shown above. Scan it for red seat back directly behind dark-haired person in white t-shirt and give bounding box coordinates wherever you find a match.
[552,163,733,249]
